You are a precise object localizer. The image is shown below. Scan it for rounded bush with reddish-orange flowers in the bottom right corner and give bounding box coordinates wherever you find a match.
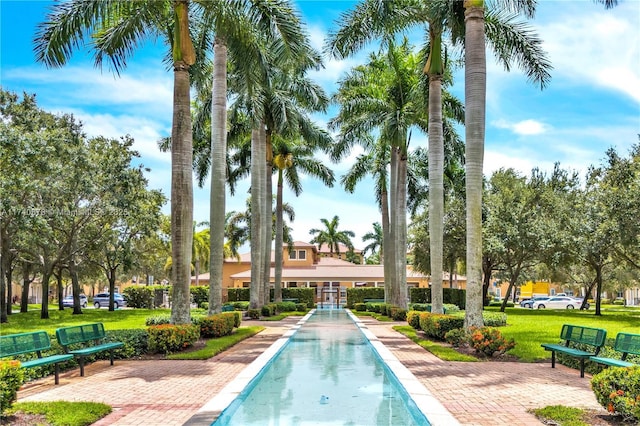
[591,366,640,422]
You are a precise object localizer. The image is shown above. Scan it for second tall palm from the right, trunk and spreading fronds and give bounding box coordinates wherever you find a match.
[329,0,549,316]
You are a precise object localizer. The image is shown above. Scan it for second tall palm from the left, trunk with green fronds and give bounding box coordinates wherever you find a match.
[190,0,316,313]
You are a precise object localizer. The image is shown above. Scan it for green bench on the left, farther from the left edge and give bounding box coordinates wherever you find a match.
[56,322,124,376]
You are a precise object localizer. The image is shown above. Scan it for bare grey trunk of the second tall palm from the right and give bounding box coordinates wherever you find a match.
[429,74,444,314]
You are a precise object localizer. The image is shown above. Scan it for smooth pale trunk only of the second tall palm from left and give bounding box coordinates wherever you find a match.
[209,38,227,315]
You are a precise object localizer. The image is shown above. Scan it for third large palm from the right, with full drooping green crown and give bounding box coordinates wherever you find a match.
[330,39,427,306]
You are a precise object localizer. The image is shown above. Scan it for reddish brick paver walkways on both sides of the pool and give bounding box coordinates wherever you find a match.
[18,318,601,426]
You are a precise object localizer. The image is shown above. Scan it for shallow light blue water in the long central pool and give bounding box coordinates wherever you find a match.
[213,310,429,426]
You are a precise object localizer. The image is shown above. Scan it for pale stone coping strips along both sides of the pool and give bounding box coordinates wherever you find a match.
[184,309,460,426]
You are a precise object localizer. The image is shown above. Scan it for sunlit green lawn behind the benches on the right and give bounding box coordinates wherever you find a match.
[487,305,640,362]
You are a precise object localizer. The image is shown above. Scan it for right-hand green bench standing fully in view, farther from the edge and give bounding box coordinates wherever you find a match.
[541,324,607,377]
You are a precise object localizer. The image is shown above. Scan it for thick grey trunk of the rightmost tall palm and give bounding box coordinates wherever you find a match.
[464,0,487,328]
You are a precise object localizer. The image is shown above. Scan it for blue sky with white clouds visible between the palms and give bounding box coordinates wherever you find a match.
[0,0,640,247]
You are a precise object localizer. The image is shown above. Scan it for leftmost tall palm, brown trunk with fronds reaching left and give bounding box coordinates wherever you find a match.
[35,0,196,324]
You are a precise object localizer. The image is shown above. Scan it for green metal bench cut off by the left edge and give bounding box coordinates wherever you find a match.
[0,331,73,385]
